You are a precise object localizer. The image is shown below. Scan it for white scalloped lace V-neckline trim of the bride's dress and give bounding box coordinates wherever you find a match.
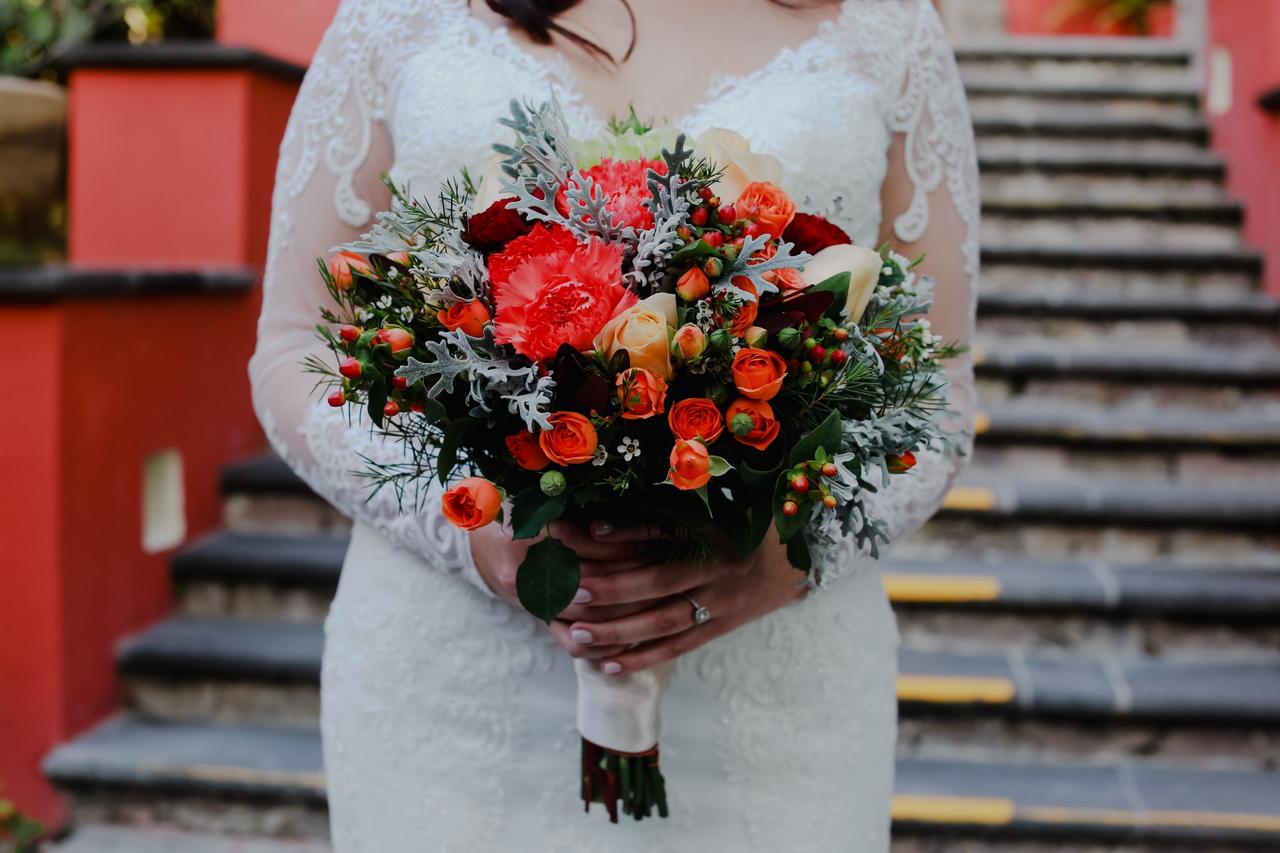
[456,0,855,133]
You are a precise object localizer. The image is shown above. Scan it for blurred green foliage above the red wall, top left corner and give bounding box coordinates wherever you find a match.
[0,0,214,77]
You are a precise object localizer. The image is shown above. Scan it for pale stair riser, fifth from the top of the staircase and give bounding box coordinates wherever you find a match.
[982,214,1242,248]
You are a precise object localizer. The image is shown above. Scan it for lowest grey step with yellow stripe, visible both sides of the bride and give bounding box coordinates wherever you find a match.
[46,717,1280,849]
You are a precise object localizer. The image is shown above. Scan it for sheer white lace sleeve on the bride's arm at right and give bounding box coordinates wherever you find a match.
[808,0,980,583]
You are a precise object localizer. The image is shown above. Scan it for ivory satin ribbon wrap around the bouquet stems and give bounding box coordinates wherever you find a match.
[573,660,676,753]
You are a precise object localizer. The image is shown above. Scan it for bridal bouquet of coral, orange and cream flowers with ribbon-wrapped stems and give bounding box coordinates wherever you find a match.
[308,102,955,821]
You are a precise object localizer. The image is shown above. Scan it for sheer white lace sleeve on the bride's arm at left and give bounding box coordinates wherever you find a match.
[250,0,489,593]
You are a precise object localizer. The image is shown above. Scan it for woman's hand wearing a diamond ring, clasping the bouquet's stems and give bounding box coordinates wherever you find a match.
[553,529,808,675]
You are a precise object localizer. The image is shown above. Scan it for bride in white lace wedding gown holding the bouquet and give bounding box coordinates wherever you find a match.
[251,0,978,853]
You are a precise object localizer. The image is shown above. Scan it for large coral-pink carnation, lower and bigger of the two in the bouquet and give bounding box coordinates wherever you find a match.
[495,238,636,361]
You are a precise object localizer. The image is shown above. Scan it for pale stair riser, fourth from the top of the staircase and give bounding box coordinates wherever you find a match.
[980,169,1224,205]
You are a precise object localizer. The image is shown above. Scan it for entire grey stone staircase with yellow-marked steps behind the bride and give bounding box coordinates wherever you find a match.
[47,40,1280,853]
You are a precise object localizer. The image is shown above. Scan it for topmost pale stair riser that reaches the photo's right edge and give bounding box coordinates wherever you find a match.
[978,315,1280,347]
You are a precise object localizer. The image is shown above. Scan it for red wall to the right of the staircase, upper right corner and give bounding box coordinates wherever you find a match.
[1208,0,1280,296]
